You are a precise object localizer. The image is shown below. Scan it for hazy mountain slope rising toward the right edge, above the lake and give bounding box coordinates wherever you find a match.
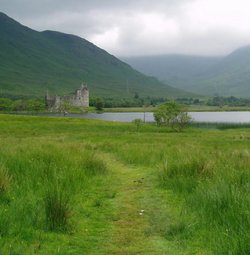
[192,47,250,97]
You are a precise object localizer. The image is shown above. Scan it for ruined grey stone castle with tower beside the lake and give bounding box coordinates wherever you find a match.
[45,84,89,111]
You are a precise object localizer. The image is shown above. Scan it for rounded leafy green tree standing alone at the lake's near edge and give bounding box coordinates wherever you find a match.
[154,101,191,132]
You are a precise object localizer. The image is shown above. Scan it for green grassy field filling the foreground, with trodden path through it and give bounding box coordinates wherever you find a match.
[0,115,250,255]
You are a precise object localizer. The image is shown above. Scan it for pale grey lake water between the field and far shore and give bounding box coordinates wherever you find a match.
[39,112,250,123]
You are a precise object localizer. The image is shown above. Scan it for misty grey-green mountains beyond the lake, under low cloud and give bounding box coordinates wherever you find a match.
[122,46,250,97]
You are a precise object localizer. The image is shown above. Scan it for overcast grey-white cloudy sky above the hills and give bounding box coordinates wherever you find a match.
[0,0,250,56]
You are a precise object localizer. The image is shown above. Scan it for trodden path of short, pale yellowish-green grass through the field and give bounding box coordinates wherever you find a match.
[101,154,180,255]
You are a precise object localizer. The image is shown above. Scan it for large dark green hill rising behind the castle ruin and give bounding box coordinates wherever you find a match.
[0,13,190,97]
